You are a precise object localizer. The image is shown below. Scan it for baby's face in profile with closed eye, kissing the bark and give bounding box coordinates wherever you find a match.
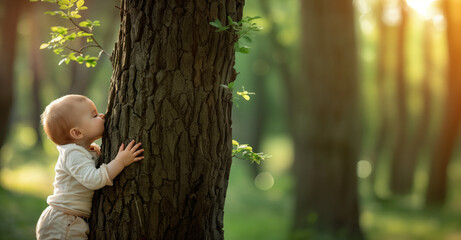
[76,99,104,143]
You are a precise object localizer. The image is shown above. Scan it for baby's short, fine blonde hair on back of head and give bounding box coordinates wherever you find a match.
[40,94,89,145]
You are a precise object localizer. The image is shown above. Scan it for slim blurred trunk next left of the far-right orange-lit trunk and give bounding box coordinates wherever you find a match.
[390,0,413,194]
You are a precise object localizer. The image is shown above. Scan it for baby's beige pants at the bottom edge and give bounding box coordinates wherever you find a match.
[35,207,90,240]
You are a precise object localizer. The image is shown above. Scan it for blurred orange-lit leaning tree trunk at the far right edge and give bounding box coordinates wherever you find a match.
[426,0,461,205]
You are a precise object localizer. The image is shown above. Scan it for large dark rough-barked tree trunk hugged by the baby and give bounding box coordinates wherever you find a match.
[90,0,244,239]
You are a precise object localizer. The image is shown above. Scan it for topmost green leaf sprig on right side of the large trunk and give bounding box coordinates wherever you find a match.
[210,16,262,54]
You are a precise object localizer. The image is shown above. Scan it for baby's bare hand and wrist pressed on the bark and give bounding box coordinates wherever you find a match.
[107,140,144,181]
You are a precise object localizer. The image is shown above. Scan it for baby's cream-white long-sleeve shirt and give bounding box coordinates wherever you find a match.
[47,143,112,217]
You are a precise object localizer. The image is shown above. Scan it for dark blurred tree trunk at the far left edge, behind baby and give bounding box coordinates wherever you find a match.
[0,0,25,166]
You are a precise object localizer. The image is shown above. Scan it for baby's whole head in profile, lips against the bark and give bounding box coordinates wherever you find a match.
[41,95,104,145]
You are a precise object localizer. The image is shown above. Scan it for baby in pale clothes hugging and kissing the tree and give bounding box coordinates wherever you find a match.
[36,95,144,239]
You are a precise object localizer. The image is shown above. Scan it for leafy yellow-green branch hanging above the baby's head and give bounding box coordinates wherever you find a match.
[30,0,109,67]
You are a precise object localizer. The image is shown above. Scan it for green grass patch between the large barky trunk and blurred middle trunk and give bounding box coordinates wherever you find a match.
[224,160,293,240]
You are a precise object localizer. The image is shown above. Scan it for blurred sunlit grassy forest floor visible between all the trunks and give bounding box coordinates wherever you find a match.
[0,141,461,240]
